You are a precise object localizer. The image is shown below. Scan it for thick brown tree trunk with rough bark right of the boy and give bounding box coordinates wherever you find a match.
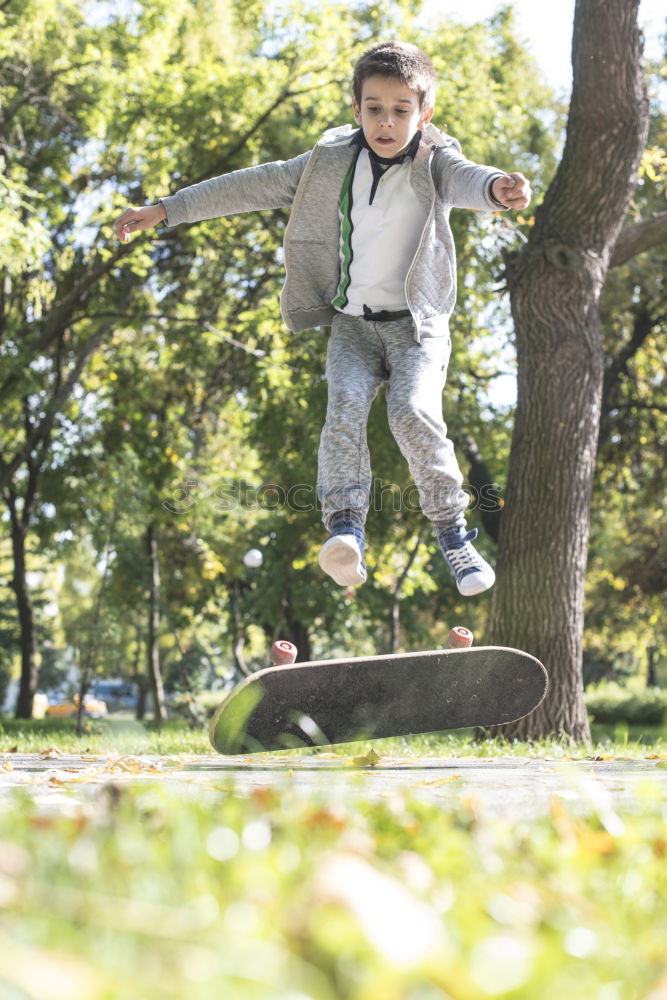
[490,0,647,741]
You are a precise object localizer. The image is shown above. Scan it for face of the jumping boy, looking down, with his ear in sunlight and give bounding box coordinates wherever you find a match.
[352,76,433,158]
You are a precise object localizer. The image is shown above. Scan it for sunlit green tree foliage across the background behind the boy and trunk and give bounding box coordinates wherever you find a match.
[0,0,664,716]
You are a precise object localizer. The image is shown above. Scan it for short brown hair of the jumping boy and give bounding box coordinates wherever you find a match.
[352,42,438,111]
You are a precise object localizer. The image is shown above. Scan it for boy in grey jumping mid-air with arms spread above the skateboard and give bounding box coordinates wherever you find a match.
[114,41,530,596]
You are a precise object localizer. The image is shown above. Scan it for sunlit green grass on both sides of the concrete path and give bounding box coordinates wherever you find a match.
[0,719,667,1000]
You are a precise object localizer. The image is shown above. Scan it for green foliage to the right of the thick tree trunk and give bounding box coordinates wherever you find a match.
[586,50,667,676]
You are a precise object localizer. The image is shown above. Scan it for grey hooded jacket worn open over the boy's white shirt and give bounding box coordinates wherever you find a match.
[162,124,502,341]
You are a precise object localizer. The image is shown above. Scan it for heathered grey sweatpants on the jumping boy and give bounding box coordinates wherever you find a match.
[317,313,468,532]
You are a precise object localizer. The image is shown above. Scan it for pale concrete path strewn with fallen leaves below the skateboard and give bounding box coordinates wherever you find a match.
[0,751,667,825]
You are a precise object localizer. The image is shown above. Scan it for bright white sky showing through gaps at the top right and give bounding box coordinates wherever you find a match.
[425,0,666,93]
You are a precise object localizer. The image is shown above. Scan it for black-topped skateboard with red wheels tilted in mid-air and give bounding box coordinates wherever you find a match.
[209,627,548,754]
